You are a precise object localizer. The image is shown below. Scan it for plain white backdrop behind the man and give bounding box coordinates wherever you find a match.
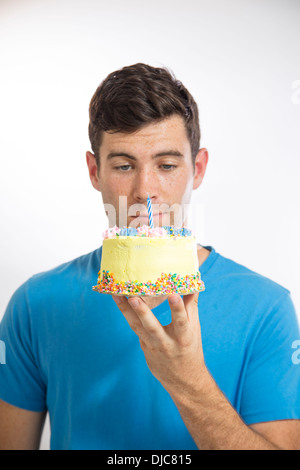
[0,0,300,449]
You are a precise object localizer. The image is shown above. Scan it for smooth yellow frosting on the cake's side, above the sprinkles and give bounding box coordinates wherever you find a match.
[99,236,198,282]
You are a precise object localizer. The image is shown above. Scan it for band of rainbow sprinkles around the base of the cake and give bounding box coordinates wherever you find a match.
[93,271,205,295]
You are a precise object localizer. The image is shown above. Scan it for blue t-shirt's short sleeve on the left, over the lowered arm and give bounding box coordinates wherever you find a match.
[0,283,46,411]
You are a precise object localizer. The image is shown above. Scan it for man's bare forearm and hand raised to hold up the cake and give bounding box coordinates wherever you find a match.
[114,294,300,450]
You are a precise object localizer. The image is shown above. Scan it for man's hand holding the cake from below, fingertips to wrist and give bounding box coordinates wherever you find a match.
[113,292,208,400]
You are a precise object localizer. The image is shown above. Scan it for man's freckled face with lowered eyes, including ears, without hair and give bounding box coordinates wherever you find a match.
[87,115,207,227]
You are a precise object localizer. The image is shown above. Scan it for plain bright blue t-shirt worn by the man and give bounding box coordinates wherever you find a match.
[0,247,300,450]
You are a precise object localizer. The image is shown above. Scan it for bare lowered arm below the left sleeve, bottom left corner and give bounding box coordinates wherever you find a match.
[0,400,46,450]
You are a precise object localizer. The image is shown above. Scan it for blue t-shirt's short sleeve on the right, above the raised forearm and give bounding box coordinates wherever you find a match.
[240,291,300,424]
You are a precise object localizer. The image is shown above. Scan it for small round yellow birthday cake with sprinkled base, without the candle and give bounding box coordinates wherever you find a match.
[93,225,204,296]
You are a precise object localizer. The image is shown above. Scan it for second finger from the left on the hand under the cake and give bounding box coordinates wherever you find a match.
[128,297,166,341]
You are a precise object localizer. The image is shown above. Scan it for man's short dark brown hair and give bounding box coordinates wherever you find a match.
[89,63,200,167]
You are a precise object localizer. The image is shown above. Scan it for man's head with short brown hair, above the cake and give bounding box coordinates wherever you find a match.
[86,64,208,227]
